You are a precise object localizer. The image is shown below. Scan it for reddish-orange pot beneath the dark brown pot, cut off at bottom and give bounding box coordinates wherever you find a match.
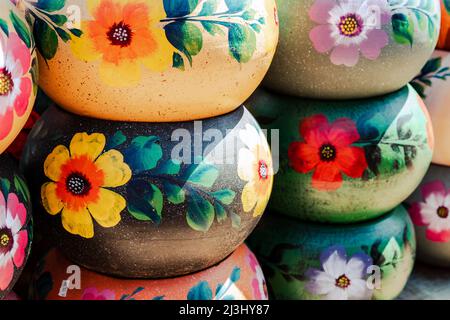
[32,245,267,300]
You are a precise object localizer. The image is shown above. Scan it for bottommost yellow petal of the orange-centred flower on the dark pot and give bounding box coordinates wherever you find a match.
[61,207,94,238]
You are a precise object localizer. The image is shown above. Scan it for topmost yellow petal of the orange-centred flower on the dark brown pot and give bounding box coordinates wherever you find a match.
[70,132,106,161]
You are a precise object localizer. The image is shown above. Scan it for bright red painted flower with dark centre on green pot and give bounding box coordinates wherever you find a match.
[288,115,367,191]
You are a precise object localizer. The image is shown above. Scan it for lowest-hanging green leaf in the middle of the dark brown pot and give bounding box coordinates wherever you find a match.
[186,189,214,232]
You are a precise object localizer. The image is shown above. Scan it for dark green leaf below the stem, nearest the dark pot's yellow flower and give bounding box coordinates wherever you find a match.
[127,180,164,224]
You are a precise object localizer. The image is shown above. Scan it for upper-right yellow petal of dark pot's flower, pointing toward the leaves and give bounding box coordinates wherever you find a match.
[95,150,131,188]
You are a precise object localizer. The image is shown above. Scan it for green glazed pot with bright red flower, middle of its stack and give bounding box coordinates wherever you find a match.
[246,86,433,223]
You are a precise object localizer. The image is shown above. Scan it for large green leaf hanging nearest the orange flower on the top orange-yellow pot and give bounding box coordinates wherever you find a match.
[164,21,203,65]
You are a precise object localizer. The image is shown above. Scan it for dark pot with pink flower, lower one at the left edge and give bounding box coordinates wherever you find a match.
[0,155,33,300]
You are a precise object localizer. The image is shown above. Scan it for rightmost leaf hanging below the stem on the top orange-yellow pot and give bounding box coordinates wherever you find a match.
[228,24,256,63]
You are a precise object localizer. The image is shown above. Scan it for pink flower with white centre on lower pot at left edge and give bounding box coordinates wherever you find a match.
[0,192,28,291]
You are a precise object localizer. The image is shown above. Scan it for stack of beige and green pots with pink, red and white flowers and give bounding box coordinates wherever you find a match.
[247,0,440,300]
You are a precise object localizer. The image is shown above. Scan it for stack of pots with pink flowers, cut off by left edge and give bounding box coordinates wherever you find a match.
[0,1,37,300]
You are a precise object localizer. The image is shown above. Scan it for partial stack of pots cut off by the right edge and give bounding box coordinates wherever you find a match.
[405,1,450,267]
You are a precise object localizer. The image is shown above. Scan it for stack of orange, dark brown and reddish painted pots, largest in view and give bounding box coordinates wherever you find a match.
[17,0,278,300]
